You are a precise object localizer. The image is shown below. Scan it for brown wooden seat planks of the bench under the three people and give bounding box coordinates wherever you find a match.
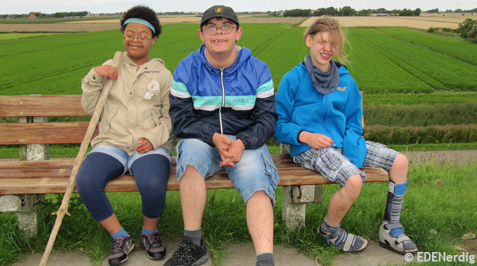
[0,154,388,195]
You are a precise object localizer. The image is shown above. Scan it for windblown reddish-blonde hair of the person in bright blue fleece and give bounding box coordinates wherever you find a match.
[303,16,351,64]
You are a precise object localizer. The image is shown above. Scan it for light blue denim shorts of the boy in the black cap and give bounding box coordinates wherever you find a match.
[176,136,279,205]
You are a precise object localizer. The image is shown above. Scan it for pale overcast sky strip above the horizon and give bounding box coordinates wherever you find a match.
[0,0,477,14]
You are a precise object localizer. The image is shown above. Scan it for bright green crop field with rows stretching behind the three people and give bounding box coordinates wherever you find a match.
[0,21,477,142]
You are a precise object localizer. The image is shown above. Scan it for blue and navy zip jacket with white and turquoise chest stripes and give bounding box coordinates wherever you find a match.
[169,45,277,149]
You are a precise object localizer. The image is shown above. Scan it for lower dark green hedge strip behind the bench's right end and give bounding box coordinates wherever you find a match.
[364,124,477,145]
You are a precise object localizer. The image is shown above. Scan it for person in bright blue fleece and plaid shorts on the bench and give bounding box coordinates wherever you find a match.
[275,17,417,254]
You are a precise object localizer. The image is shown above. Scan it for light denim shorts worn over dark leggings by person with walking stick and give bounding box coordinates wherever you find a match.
[89,145,171,174]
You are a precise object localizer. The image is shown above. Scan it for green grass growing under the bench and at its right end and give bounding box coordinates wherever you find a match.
[0,161,477,266]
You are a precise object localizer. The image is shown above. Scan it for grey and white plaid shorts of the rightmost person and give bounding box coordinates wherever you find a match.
[293,141,399,187]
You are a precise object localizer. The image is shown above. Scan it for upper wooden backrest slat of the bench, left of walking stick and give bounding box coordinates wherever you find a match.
[0,94,87,117]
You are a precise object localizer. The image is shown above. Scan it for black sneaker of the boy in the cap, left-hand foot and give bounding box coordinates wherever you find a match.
[164,239,208,266]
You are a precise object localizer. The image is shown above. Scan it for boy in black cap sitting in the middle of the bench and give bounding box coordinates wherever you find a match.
[165,5,279,265]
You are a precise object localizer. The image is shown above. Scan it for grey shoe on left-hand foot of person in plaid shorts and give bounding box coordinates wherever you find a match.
[318,225,368,252]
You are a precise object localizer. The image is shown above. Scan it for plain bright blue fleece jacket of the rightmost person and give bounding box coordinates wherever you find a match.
[275,63,366,168]
